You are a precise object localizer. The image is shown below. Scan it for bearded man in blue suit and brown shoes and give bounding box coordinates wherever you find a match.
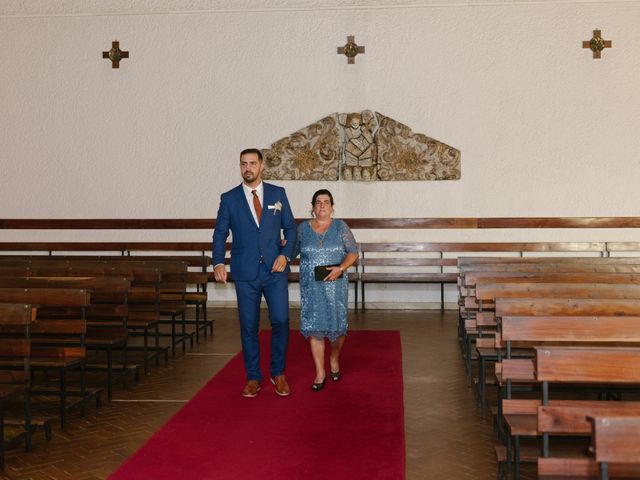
[213,148,296,397]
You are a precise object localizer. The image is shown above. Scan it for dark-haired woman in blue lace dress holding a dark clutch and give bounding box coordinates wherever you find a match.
[296,189,358,391]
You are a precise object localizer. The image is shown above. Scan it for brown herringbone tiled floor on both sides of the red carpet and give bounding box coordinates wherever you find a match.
[5,309,535,480]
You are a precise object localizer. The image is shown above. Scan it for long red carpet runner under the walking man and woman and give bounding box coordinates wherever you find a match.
[110,331,405,480]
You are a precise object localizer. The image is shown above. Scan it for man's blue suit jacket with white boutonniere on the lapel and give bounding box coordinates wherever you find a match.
[213,182,296,281]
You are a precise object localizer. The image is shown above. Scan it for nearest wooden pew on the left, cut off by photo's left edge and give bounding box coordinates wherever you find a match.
[0,303,36,472]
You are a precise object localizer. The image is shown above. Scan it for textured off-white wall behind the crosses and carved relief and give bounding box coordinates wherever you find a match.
[0,0,640,306]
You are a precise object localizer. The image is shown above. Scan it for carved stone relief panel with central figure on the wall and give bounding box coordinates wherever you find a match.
[263,110,460,181]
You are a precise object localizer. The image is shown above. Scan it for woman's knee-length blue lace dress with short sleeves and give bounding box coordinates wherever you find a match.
[296,219,358,341]
